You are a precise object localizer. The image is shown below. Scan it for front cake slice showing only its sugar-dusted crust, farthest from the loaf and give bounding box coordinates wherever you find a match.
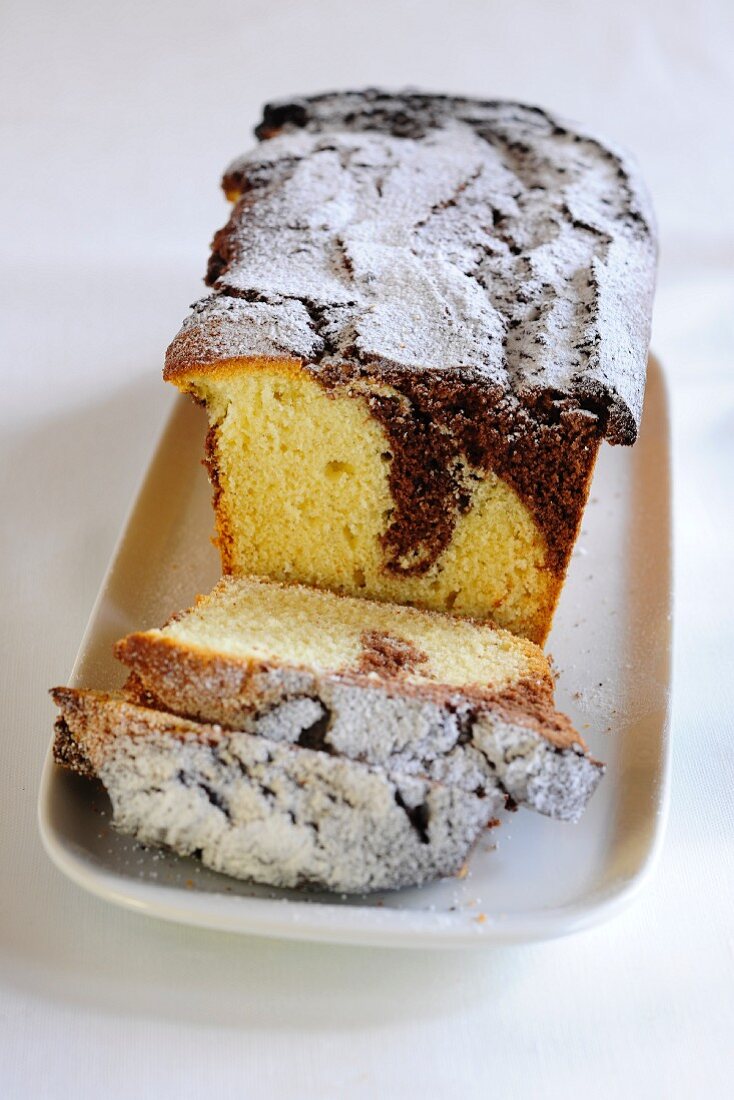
[52,688,504,892]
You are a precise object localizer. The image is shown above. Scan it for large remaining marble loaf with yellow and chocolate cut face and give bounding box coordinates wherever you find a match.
[164,89,656,644]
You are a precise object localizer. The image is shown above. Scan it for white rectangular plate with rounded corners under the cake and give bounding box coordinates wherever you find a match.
[39,360,671,947]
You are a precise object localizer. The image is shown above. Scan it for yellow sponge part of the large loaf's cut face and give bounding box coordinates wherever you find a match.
[186,362,560,641]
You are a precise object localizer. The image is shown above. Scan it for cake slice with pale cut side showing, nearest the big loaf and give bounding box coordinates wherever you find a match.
[116,576,603,821]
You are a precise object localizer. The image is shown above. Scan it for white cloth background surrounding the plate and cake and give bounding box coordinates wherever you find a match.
[0,0,734,1100]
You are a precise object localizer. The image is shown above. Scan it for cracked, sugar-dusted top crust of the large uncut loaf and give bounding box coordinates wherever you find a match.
[165,89,656,443]
